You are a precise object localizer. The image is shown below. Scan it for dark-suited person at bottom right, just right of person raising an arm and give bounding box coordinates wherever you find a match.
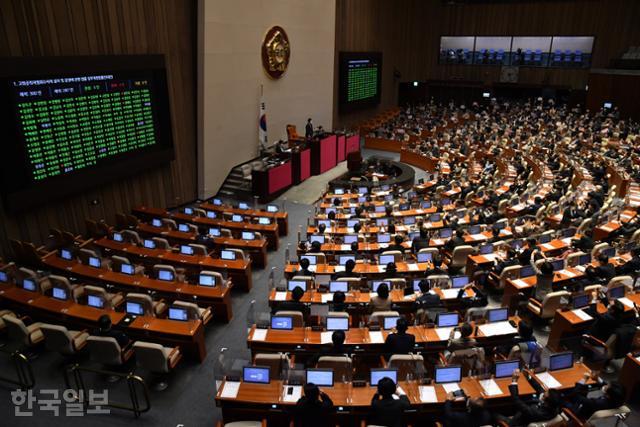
[566,372,626,420]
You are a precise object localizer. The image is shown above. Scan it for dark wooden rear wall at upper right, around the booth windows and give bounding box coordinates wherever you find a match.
[334,0,640,127]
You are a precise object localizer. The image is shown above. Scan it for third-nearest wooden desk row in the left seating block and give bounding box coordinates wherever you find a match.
[91,238,253,292]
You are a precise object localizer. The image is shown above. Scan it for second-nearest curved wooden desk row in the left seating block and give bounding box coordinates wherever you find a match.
[43,254,233,322]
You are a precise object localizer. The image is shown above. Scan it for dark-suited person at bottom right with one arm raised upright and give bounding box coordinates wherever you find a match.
[509,370,562,426]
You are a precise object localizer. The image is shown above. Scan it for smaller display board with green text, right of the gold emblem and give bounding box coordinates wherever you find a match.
[339,52,382,111]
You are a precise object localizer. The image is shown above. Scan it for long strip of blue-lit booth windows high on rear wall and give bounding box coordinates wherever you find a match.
[439,36,595,68]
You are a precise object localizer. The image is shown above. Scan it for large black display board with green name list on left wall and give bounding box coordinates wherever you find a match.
[0,55,173,210]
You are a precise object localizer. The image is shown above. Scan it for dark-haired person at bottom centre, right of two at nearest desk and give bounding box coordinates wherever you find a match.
[369,377,411,427]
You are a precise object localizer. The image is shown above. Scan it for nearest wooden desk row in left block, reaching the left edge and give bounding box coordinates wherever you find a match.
[0,285,207,362]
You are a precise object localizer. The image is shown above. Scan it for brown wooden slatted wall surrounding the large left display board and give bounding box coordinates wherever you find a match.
[0,0,196,253]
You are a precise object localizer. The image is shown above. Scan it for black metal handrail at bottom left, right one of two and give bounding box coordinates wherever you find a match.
[64,363,151,418]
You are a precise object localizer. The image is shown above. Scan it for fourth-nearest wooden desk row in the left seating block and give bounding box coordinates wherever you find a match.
[131,223,267,268]
